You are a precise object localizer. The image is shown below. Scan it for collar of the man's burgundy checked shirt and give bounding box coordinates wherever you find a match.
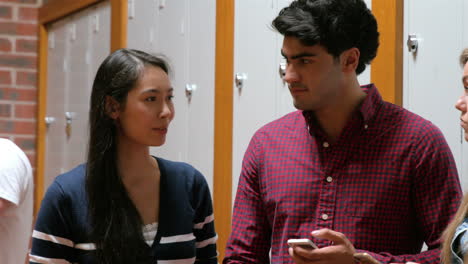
[302,84,383,126]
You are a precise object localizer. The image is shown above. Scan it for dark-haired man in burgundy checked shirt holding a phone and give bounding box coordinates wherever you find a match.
[224,0,461,264]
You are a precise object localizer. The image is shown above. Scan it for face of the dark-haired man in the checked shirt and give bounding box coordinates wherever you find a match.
[281,36,343,111]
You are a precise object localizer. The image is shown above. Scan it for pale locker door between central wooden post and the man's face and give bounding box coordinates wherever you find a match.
[232,0,280,200]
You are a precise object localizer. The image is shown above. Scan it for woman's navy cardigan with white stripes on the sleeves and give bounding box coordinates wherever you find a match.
[29,158,217,264]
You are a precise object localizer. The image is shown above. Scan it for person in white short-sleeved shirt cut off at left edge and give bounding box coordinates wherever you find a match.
[0,138,34,264]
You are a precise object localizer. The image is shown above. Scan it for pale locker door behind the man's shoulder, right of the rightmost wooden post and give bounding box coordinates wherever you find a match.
[403,0,467,186]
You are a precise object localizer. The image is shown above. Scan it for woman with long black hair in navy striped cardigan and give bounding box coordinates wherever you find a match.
[30,49,217,264]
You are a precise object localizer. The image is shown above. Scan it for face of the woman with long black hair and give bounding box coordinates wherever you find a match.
[116,66,174,146]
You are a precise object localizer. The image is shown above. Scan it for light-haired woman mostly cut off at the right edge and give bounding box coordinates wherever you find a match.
[442,49,468,264]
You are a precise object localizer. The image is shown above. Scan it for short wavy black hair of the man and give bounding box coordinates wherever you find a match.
[272,0,379,74]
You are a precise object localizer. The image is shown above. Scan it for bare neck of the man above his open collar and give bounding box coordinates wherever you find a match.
[314,85,367,143]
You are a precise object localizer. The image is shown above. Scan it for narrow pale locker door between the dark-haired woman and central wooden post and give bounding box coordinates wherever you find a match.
[186,0,216,191]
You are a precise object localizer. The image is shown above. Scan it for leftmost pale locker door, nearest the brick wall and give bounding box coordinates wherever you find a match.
[41,19,68,189]
